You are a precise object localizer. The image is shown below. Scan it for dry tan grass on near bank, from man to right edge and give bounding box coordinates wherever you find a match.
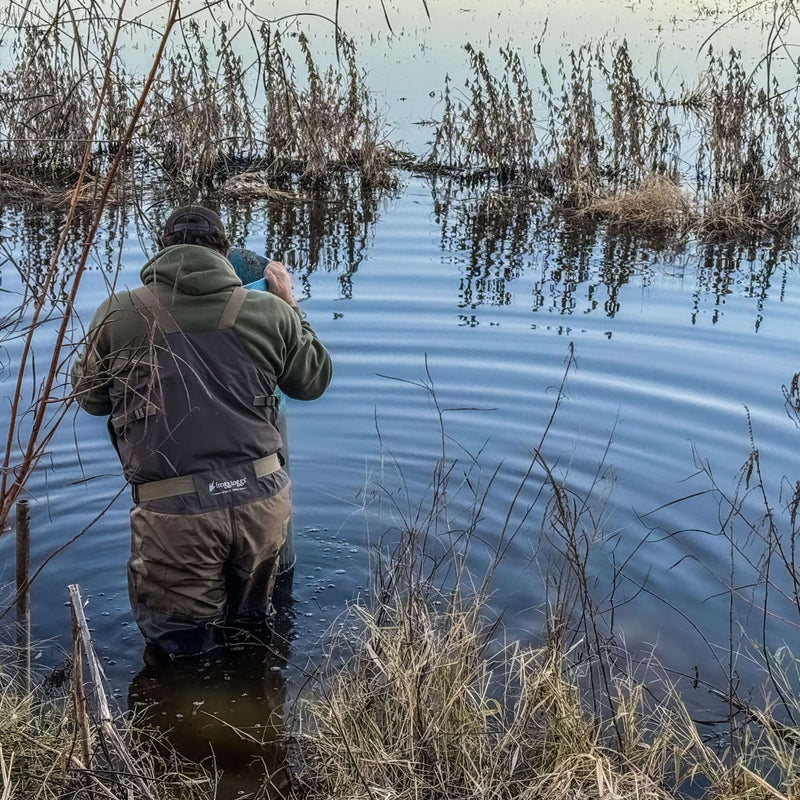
[292,532,800,800]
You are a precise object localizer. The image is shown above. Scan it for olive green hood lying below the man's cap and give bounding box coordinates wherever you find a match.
[139,244,242,295]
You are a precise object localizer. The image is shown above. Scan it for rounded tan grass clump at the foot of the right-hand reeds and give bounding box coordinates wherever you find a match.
[579,173,697,235]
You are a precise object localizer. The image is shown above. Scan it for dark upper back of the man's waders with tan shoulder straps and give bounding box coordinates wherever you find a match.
[109,286,281,483]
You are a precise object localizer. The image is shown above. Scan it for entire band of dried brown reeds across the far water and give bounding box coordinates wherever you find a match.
[0,10,800,240]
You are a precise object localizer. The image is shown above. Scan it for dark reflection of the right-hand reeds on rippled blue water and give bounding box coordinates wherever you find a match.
[431,179,795,330]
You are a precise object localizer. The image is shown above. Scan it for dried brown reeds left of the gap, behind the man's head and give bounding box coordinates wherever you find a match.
[0,16,397,202]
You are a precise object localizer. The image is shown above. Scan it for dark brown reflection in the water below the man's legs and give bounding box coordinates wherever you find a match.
[128,607,294,800]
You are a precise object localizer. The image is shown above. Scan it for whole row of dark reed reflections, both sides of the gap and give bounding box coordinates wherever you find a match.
[0,176,795,333]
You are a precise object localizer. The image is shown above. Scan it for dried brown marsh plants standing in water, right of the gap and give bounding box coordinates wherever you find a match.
[425,41,800,240]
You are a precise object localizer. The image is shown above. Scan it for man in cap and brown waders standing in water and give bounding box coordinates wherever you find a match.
[72,206,331,658]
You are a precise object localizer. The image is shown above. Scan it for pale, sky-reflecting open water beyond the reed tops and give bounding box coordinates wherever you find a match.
[0,0,792,151]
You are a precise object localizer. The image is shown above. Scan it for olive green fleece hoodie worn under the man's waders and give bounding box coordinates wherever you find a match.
[72,244,332,416]
